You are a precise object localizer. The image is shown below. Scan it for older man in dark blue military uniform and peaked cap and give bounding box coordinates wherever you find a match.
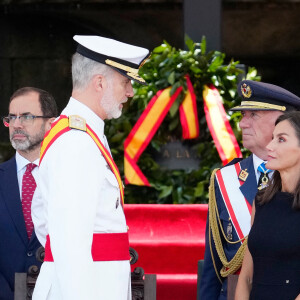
[199,80,300,300]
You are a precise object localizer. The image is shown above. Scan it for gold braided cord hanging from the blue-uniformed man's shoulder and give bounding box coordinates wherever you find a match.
[208,169,248,283]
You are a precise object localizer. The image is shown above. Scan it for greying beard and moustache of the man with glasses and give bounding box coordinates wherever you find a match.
[10,125,45,152]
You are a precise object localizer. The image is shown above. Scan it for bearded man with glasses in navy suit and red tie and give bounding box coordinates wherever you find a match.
[0,87,58,300]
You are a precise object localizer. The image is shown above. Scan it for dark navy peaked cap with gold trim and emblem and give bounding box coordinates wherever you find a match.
[230,80,300,112]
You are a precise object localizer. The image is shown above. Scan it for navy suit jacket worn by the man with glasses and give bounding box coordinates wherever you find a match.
[0,157,41,300]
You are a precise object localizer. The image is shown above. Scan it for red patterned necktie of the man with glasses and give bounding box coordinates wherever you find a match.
[22,163,36,239]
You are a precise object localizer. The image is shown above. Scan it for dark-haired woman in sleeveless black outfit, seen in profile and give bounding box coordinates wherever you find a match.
[235,112,300,300]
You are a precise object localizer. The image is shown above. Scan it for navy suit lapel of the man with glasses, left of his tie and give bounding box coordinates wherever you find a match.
[0,157,28,245]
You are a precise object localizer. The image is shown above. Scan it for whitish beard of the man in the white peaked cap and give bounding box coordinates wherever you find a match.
[101,84,127,119]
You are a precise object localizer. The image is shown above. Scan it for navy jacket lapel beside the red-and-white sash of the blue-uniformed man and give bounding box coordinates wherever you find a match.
[240,155,257,205]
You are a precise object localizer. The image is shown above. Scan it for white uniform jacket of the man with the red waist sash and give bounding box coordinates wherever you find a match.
[32,98,131,300]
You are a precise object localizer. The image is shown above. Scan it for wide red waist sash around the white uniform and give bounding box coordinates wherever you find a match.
[44,232,130,262]
